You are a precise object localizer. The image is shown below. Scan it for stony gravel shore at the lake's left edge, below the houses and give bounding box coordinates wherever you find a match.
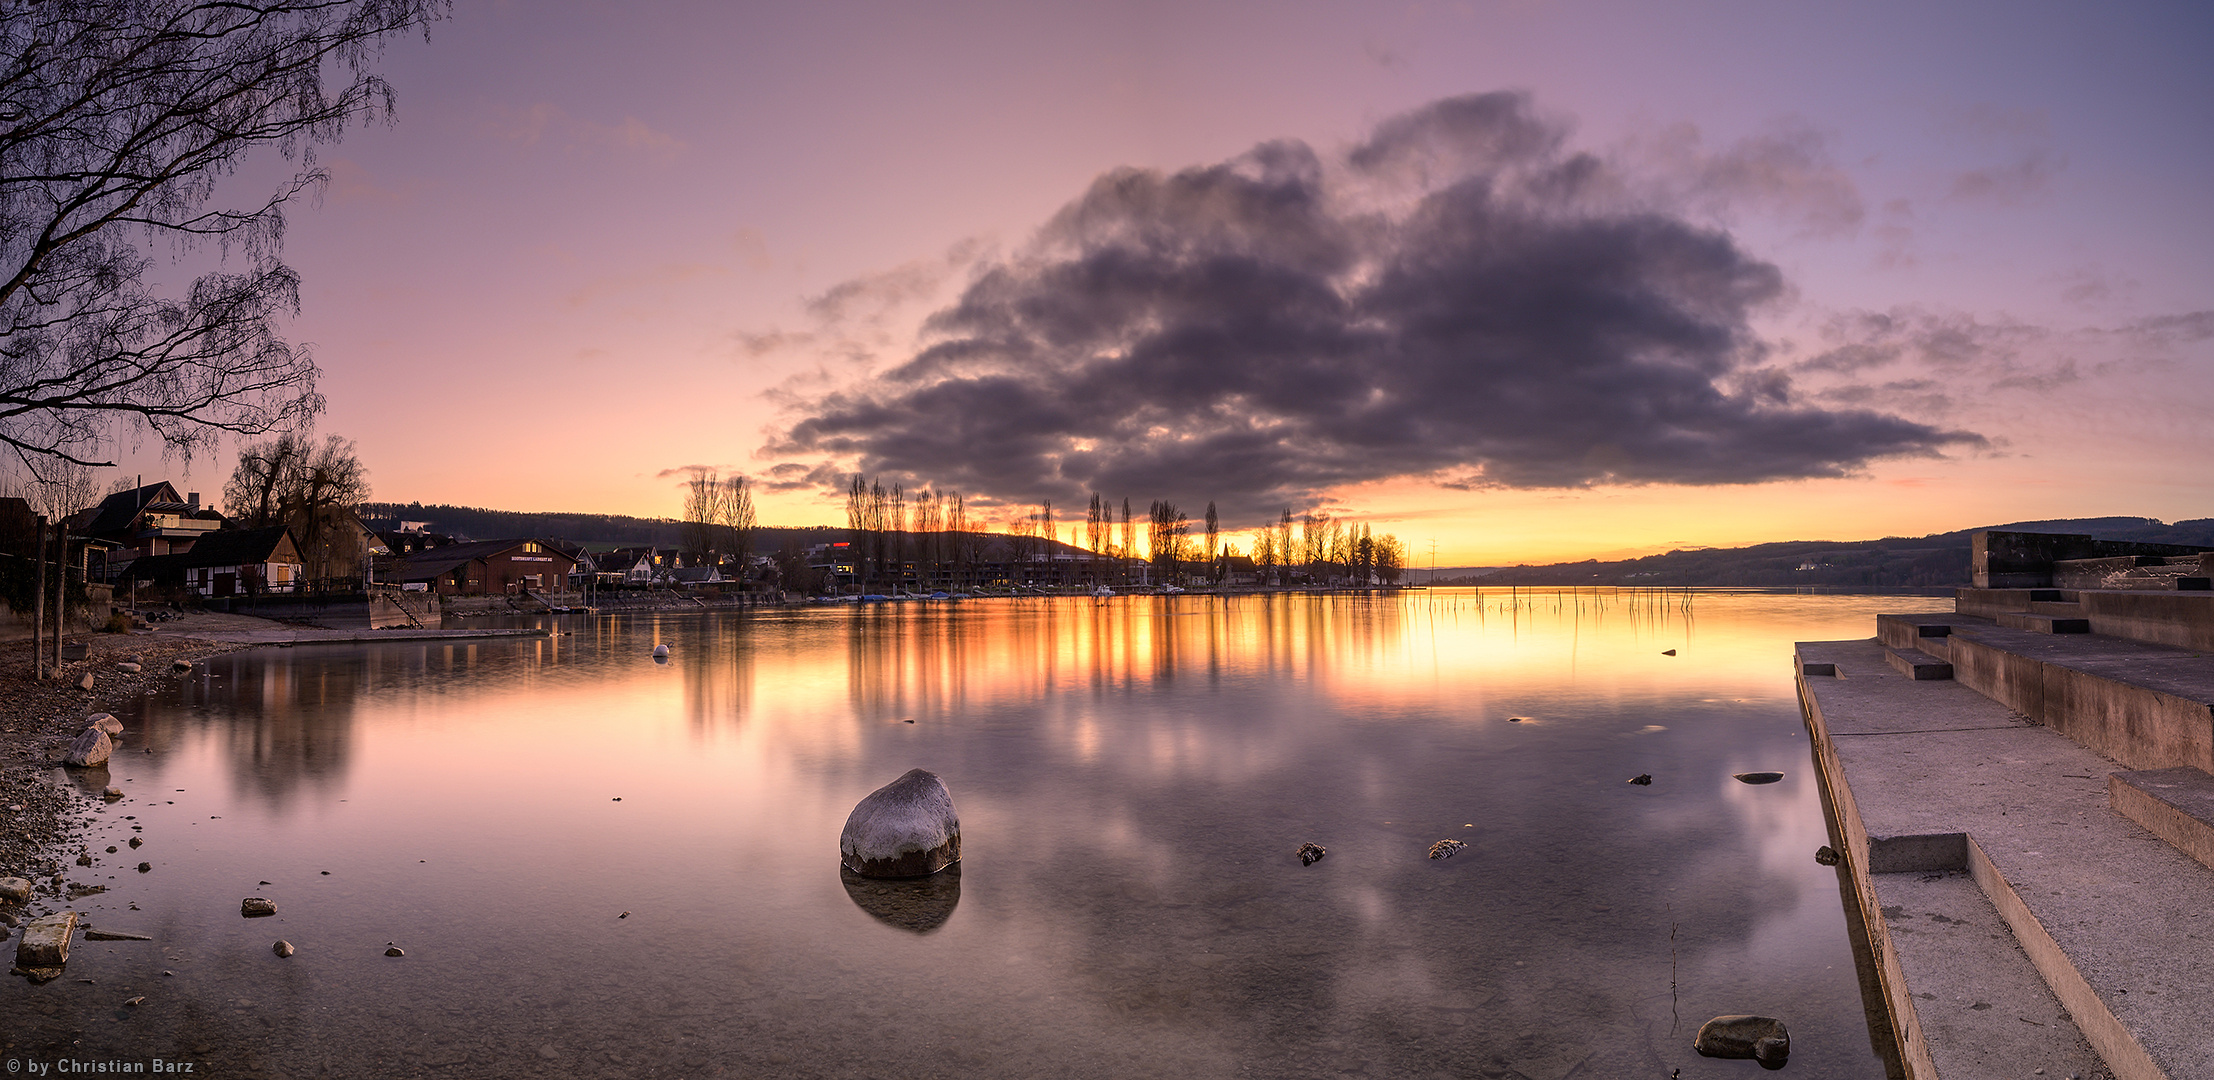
[0,615,270,898]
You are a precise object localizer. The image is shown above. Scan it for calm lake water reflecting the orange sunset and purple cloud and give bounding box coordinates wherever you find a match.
[0,591,1948,1080]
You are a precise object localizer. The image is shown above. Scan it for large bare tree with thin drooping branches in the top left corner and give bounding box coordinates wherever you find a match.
[0,0,447,469]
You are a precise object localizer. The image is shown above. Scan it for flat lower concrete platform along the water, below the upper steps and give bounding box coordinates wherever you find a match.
[1798,637,2214,1080]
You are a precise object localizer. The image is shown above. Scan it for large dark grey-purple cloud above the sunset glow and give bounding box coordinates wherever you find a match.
[768,95,1982,520]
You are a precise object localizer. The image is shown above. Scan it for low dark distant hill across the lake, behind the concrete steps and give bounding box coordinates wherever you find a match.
[1435,518,2214,589]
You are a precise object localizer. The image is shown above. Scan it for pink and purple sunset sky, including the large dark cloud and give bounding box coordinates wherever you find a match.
[116,0,2214,567]
